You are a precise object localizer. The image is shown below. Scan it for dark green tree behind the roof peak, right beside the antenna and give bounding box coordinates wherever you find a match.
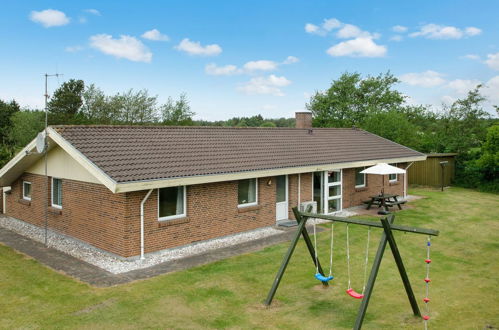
[47,79,85,124]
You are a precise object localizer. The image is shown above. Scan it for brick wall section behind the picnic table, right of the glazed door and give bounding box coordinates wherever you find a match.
[342,163,406,208]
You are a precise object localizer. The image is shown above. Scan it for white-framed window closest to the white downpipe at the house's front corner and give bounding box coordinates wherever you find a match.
[158,186,186,221]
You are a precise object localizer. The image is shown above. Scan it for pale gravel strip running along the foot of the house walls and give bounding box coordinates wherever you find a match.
[0,216,282,274]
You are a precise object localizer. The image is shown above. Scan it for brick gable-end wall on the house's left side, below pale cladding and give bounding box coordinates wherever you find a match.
[6,173,126,255]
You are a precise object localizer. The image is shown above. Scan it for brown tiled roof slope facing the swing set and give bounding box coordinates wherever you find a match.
[54,126,423,183]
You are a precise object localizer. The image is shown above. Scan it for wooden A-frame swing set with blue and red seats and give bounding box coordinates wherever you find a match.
[265,207,439,329]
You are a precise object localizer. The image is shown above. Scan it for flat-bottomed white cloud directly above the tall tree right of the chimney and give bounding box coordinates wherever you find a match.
[326,37,386,57]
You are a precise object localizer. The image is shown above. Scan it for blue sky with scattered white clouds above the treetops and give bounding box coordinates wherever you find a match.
[0,0,499,120]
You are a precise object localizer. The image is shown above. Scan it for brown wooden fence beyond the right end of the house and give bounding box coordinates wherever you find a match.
[407,153,457,186]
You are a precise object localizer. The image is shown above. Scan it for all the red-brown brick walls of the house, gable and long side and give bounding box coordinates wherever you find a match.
[2,165,404,257]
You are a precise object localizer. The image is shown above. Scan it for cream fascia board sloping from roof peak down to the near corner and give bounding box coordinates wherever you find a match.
[47,127,116,193]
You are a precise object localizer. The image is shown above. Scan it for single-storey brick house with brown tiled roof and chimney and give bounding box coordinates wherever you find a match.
[0,112,426,257]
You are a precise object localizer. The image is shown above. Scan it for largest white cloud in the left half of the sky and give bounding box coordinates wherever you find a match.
[90,34,152,62]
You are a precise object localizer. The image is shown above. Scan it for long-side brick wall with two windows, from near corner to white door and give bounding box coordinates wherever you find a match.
[125,178,276,256]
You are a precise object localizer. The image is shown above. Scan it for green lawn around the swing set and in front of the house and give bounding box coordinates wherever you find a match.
[0,188,499,329]
